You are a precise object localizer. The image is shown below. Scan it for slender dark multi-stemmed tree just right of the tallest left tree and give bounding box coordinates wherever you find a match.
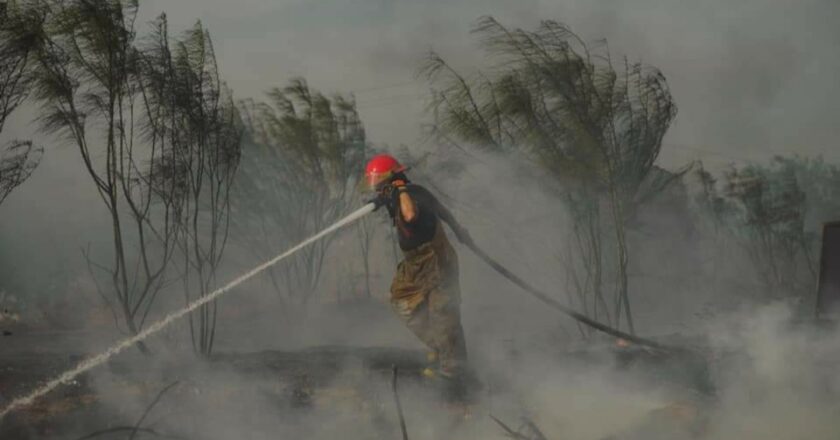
[140,15,242,355]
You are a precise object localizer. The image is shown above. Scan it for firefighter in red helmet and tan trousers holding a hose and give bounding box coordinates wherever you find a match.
[365,154,472,383]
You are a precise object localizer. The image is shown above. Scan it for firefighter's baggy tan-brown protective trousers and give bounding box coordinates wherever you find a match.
[391,223,467,378]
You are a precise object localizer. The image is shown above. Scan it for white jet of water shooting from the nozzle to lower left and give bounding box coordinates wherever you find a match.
[0,203,375,420]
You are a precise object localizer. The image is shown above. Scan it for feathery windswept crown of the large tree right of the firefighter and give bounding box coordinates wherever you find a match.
[421,17,676,198]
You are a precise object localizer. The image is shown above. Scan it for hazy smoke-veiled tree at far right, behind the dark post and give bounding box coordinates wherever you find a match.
[697,157,840,300]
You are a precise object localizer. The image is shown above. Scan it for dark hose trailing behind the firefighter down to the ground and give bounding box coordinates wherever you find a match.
[464,240,677,351]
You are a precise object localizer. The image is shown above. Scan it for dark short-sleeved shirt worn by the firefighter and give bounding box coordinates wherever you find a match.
[389,184,452,251]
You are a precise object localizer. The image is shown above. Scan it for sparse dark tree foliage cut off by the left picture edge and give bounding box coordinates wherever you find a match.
[0,3,43,203]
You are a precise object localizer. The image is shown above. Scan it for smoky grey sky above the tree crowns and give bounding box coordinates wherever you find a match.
[135,0,840,166]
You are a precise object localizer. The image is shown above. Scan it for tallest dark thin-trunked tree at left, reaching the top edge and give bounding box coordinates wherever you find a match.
[16,0,176,351]
